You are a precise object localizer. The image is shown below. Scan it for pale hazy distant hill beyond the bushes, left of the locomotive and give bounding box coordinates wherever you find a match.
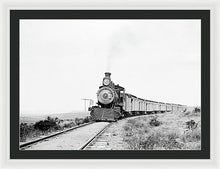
[20,112,90,123]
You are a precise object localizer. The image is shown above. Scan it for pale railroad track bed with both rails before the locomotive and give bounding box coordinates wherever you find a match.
[20,122,111,150]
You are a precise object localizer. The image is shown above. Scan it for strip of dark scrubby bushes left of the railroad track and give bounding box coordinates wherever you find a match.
[20,116,91,142]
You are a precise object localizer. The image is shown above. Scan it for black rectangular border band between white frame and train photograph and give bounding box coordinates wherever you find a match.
[10,10,210,159]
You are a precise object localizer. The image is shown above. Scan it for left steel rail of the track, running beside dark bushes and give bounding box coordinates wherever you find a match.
[19,122,94,149]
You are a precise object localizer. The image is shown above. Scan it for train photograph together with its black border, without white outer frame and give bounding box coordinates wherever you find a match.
[10,10,210,159]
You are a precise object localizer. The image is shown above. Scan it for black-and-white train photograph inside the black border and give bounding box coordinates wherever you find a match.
[20,20,201,150]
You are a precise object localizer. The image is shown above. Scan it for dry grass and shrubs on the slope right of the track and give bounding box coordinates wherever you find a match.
[124,108,201,150]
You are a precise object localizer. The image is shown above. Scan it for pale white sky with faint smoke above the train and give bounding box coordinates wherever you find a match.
[20,19,201,115]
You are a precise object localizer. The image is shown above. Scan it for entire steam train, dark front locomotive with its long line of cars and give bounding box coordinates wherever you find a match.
[89,72,187,121]
